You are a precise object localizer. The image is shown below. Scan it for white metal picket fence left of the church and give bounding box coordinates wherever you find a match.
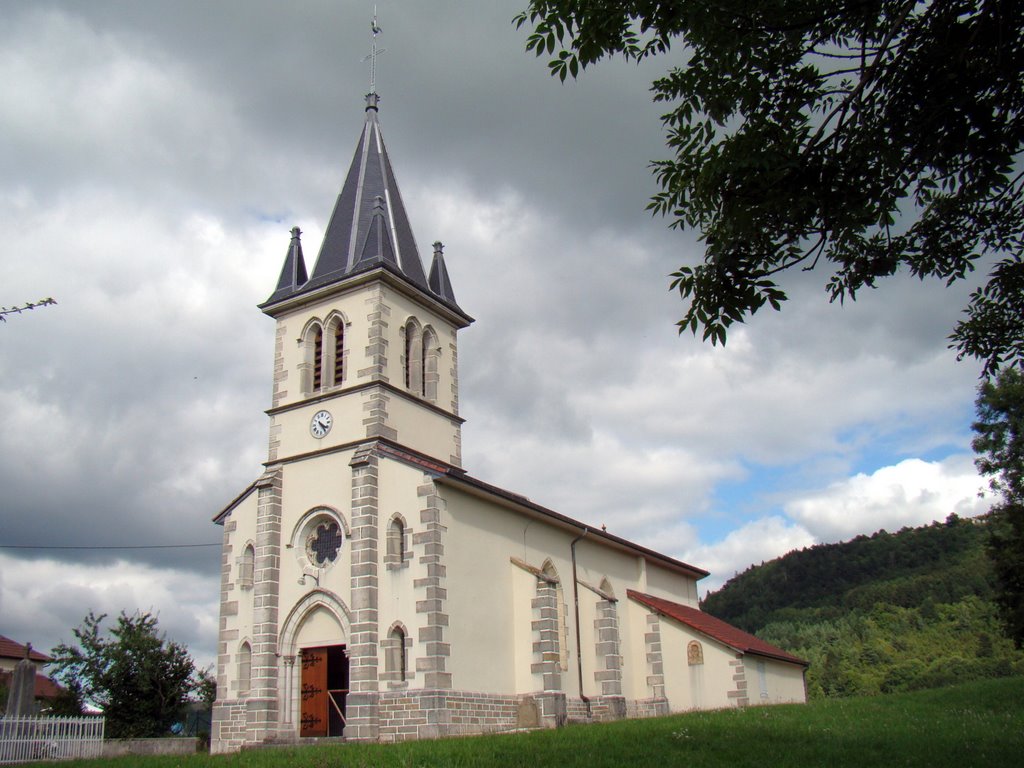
[0,717,104,765]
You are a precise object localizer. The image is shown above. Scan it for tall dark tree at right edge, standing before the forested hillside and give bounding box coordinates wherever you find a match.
[972,368,1024,648]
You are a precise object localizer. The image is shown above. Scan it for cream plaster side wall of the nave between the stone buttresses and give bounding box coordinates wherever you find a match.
[440,484,696,698]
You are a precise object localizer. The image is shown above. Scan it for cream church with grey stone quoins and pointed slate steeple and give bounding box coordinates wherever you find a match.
[211,89,807,753]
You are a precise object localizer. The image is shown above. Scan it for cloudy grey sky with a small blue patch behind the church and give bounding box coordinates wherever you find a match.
[0,0,988,664]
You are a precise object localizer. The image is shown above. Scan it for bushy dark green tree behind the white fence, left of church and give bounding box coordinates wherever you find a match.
[52,611,200,738]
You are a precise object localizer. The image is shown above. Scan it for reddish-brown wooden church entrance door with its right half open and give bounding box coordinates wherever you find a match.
[299,645,348,736]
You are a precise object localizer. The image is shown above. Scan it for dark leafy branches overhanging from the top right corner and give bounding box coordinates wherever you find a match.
[515,0,1024,374]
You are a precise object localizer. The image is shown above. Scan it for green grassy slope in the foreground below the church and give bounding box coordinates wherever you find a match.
[36,678,1024,768]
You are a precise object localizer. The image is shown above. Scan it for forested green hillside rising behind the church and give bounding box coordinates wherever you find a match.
[701,515,1024,696]
